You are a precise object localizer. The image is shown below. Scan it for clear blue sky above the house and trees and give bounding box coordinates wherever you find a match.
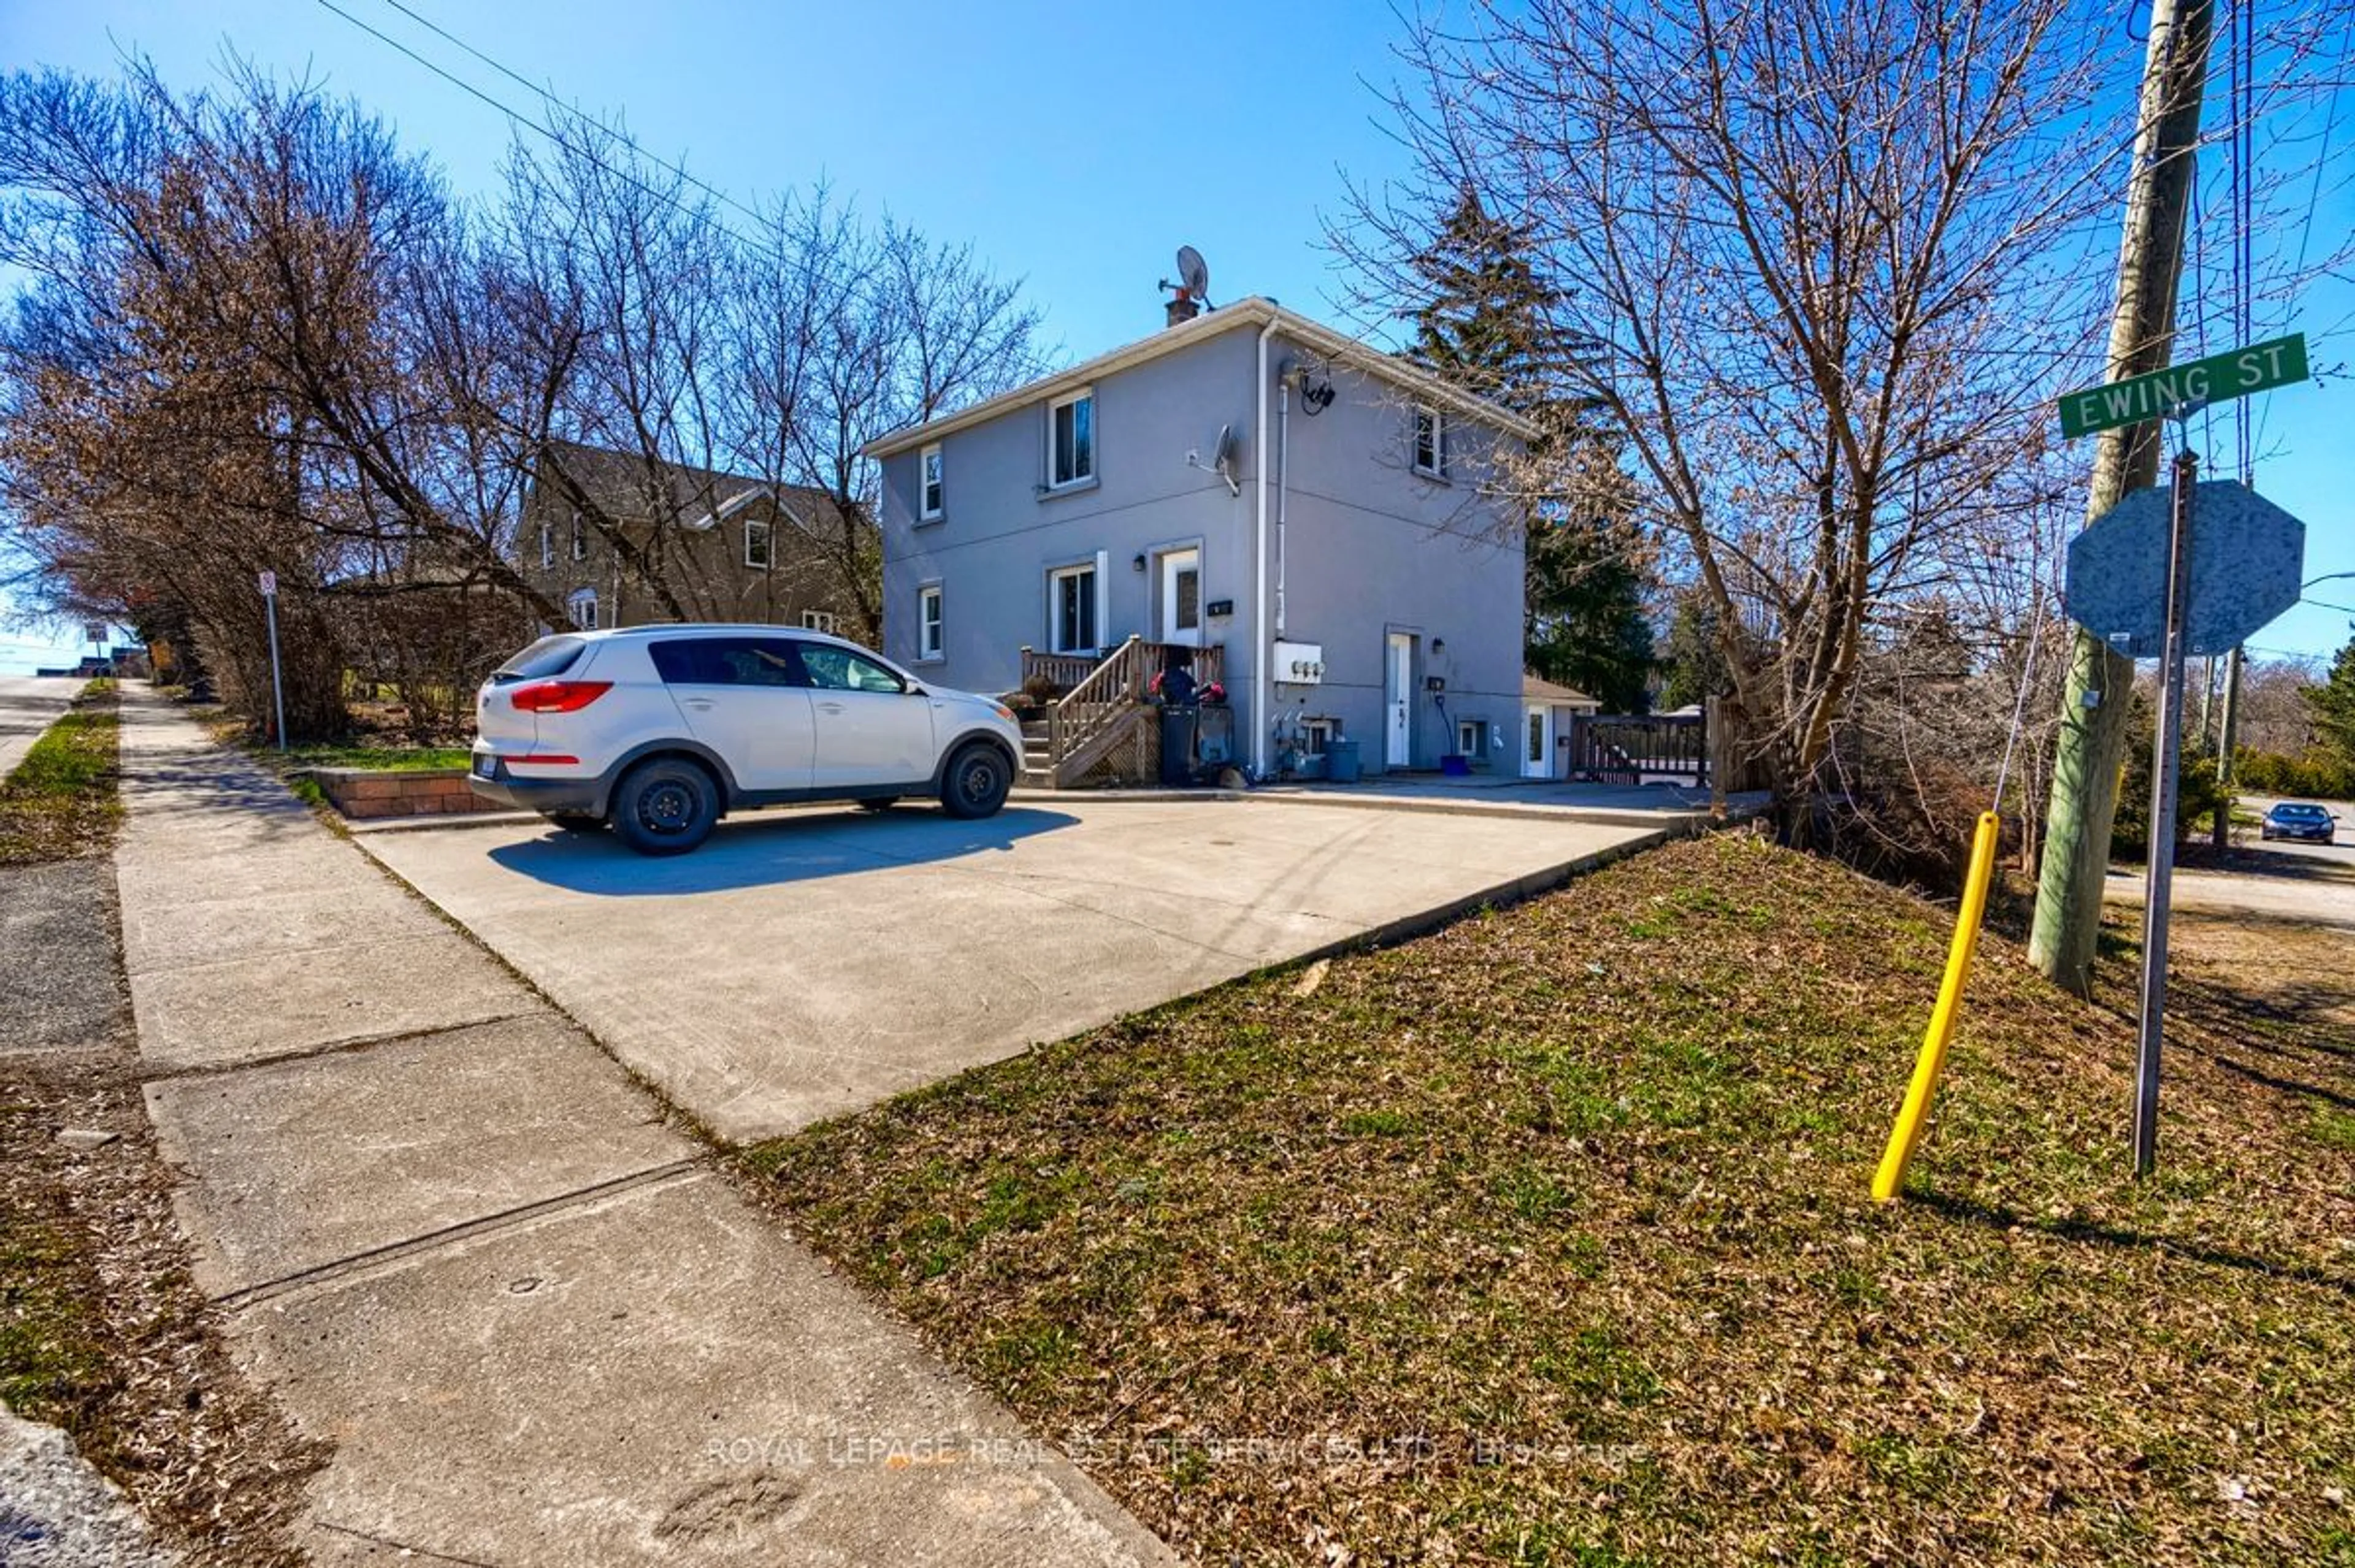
[0,0,2355,668]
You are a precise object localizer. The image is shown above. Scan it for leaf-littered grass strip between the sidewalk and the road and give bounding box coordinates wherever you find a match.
[0,692,320,1568]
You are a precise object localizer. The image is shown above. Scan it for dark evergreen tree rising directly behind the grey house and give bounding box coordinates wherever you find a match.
[1408,191,1653,713]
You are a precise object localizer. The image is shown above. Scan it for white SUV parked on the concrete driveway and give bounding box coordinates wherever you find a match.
[469,626,1022,855]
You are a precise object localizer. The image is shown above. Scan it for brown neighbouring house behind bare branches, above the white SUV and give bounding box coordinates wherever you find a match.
[518,443,878,643]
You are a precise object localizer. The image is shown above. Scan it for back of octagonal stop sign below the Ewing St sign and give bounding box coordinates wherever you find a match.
[2066,480,2305,659]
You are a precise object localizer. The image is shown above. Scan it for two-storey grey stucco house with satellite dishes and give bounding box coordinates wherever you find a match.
[867,299,1531,774]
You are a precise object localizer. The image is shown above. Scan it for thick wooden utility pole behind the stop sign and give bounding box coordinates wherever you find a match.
[2028,0,2216,996]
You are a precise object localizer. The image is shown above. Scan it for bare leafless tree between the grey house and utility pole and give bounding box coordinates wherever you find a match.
[1342,0,2280,831]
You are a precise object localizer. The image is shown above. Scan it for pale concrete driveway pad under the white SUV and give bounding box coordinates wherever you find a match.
[361,798,1684,1142]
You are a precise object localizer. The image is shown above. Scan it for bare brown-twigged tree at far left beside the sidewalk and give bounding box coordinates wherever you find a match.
[0,64,565,732]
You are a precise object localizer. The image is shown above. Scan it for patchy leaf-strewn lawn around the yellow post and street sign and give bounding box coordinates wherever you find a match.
[742,836,2355,1568]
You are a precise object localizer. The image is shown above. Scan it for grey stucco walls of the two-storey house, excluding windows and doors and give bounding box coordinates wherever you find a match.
[883,306,1522,770]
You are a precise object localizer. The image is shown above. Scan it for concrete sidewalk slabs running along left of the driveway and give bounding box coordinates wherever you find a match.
[118,687,1173,1568]
